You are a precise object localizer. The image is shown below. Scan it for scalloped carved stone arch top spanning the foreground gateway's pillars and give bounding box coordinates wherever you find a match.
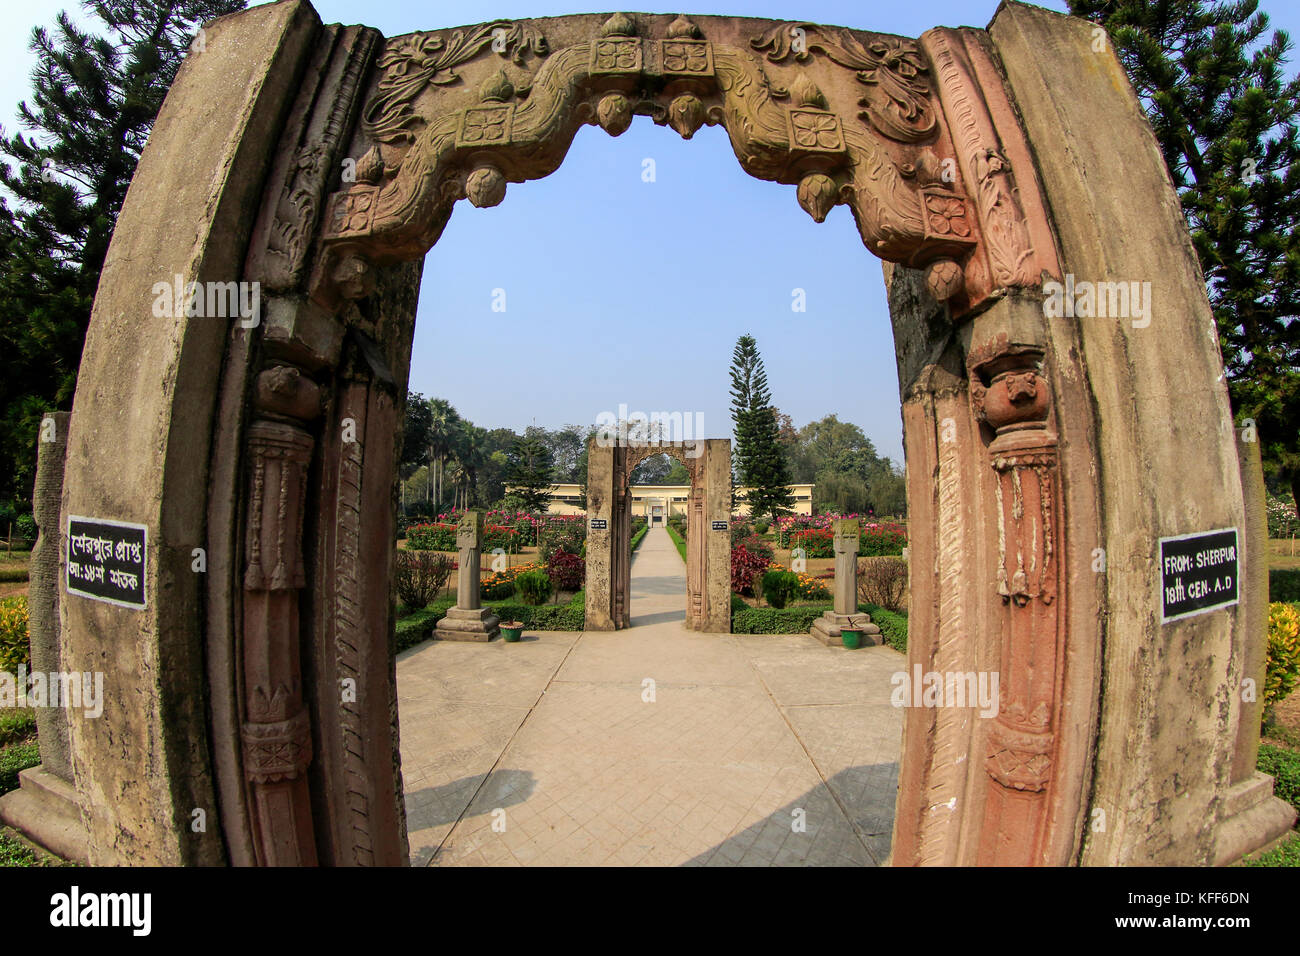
[312,13,1054,316]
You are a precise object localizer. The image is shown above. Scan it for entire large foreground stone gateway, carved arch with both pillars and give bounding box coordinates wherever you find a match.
[32,0,1294,865]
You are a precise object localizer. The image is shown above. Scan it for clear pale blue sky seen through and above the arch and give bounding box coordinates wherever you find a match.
[0,0,1300,462]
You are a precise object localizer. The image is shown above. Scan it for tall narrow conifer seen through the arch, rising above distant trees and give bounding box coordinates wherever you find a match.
[731,336,794,518]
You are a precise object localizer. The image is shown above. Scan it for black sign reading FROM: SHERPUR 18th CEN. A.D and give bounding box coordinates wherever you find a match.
[1160,528,1240,624]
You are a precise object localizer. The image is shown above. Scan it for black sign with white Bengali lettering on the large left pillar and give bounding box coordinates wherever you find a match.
[65,515,148,607]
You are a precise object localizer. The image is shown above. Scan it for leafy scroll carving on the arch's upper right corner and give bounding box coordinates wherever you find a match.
[750,23,937,143]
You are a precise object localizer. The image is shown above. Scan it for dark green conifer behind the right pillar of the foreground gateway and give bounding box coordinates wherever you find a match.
[1070,0,1300,503]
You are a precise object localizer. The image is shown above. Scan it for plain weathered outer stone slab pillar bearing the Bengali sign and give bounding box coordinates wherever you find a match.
[52,1,320,865]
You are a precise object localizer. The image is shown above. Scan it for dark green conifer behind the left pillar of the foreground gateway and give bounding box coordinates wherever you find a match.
[0,0,244,497]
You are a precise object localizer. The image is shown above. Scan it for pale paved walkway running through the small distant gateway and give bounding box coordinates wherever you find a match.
[398,528,905,866]
